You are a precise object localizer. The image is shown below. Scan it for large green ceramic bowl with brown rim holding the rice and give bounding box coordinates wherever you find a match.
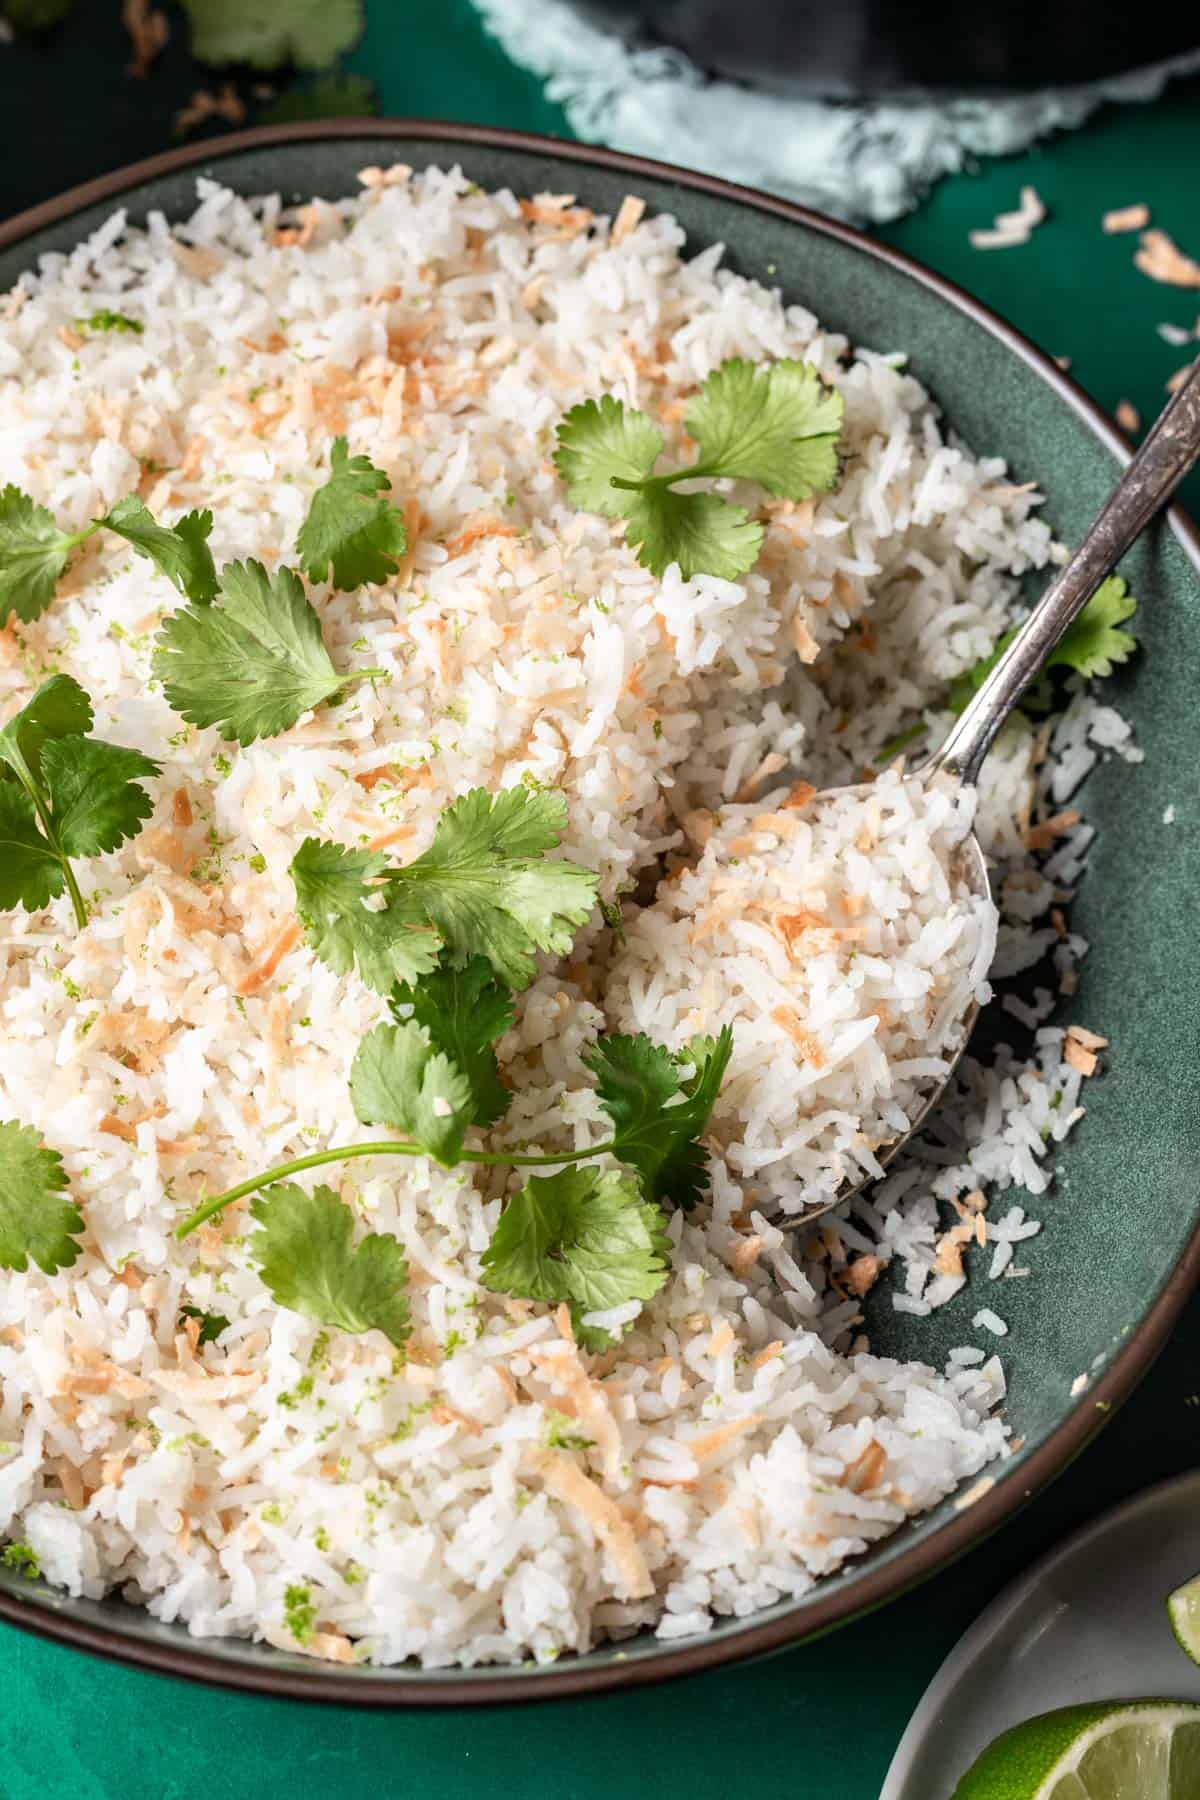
[0,121,1200,1706]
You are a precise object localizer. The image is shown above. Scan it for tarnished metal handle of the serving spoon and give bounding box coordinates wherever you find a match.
[927,362,1200,783]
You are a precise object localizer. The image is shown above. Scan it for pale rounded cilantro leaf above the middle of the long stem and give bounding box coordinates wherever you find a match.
[351,1019,475,1168]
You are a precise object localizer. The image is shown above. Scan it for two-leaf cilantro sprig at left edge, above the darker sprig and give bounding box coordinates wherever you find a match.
[0,482,216,623]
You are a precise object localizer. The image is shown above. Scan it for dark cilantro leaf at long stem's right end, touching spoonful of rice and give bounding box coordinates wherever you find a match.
[583,1026,734,1210]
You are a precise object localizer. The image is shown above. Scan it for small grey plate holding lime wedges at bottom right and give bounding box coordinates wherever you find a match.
[880,1472,1200,1800]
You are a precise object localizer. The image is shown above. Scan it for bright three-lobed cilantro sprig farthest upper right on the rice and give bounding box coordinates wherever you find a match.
[554,356,844,581]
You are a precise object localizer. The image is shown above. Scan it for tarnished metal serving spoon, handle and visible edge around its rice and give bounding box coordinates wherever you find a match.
[774,362,1200,1226]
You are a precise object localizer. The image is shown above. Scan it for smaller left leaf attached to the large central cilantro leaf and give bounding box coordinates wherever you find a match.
[291,837,441,994]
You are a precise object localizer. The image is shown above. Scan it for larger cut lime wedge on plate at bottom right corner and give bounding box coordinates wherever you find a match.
[954,1699,1200,1800]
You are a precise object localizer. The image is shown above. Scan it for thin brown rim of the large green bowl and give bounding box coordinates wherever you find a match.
[0,117,1200,1708]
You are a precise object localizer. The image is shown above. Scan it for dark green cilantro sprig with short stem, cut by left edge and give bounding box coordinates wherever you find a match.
[0,675,158,931]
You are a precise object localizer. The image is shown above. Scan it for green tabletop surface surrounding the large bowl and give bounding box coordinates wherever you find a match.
[0,0,1200,1800]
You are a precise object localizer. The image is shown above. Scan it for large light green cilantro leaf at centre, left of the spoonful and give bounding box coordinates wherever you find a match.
[387,787,596,988]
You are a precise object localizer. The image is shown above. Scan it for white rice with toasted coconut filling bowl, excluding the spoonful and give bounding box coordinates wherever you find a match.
[0,171,1137,1665]
